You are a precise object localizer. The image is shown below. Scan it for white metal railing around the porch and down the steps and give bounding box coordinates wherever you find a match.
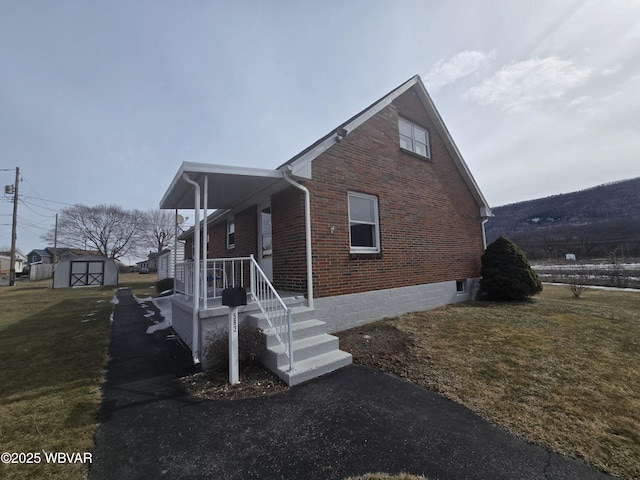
[175,255,293,370]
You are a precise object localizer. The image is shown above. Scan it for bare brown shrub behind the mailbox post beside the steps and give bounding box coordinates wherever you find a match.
[205,325,267,368]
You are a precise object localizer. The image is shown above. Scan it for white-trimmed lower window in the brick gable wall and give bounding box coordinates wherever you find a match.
[349,192,380,253]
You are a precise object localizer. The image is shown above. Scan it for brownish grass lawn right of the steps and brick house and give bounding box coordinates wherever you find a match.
[339,285,640,479]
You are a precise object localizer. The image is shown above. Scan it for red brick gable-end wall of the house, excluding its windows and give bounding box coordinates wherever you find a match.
[273,86,483,298]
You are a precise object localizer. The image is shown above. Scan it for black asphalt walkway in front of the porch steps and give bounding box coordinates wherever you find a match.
[89,290,612,480]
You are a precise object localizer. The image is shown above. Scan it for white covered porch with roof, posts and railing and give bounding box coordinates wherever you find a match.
[160,162,324,378]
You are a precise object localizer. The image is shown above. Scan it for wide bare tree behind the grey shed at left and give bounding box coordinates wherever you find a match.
[42,204,145,259]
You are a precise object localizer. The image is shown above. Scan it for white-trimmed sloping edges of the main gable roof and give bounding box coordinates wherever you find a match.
[278,75,492,217]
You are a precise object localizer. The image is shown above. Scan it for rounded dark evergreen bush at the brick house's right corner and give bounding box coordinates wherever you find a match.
[480,236,542,301]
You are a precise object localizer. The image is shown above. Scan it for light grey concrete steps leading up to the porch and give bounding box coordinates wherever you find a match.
[247,306,352,386]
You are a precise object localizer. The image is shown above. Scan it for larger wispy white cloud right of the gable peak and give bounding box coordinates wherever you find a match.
[463,56,591,112]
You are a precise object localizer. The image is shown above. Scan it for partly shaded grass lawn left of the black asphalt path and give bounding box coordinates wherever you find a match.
[0,274,155,479]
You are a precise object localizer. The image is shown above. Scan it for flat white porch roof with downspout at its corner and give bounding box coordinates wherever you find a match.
[160,162,288,210]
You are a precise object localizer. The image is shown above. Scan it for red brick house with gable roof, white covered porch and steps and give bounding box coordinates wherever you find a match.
[160,76,491,384]
